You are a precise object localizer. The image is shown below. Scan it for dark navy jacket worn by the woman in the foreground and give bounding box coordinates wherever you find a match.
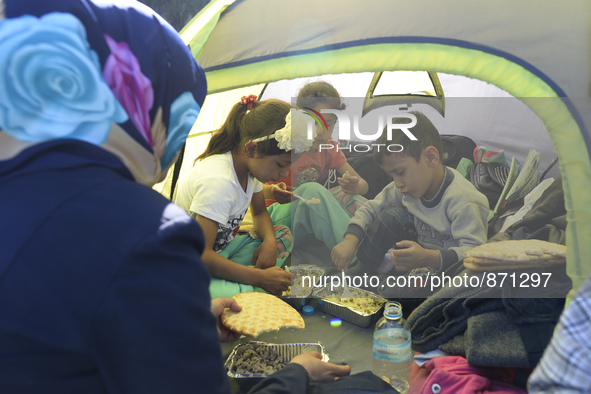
[0,140,308,394]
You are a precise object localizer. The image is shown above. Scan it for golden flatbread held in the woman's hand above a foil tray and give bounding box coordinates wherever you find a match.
[220,292,305,338]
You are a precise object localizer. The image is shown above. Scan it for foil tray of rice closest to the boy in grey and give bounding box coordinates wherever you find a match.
[313,287,388,328]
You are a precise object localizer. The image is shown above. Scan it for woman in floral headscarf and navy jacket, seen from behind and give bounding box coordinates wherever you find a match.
[0,0,236,394]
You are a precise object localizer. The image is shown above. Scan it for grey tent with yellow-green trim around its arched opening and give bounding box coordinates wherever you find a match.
[155,0,591,390]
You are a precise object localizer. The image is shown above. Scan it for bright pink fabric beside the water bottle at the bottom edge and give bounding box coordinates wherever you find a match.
[408,356,527,394]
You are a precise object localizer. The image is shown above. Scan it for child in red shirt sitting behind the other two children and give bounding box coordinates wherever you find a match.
[264,81,369,217]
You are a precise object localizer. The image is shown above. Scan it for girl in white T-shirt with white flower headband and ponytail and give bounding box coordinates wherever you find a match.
[175,95,311,298]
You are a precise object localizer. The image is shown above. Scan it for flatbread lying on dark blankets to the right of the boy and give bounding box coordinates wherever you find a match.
[464,239,566,262]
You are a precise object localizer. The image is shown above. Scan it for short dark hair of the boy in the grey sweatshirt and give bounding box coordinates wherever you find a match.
[374,111,442,164]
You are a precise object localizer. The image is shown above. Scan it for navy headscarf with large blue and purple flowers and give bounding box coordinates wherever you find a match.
[0,0,207,185]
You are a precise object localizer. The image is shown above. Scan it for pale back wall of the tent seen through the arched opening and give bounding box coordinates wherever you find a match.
[169,71,559,182]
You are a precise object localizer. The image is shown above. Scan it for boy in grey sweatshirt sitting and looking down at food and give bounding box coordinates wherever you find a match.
[331,112,488,274]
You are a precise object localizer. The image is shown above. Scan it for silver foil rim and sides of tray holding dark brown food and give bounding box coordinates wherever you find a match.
[224,341,329,390]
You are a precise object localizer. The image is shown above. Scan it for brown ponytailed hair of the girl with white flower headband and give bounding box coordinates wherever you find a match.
[197,99,290,160]
